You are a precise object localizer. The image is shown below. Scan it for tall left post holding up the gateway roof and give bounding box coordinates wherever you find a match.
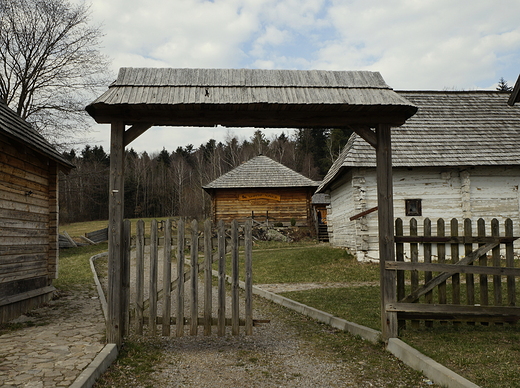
[107,122,125,347]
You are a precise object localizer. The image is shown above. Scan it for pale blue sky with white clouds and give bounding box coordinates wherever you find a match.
[71,0,520,153]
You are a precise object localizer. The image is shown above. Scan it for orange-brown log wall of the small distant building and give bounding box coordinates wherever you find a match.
[213,188,312,226]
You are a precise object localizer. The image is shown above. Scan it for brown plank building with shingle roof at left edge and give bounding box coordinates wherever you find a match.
[0,102,73,323]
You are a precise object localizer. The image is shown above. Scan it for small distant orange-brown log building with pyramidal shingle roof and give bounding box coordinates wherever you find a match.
[203,155,319,226]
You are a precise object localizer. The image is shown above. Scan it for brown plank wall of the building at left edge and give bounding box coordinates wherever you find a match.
[0,135,54,297]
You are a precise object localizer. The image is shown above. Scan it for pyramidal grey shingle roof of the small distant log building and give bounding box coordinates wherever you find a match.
[203,155,319,190]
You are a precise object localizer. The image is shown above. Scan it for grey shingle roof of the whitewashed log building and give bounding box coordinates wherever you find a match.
[318,91,520,192]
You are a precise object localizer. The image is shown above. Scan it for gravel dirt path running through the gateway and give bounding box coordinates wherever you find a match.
[95,250,432,388]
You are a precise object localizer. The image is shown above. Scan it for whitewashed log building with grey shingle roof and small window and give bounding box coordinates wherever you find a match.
[317,91,520,260]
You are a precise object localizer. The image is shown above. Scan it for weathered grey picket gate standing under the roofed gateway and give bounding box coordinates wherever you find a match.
[127,219,253,337]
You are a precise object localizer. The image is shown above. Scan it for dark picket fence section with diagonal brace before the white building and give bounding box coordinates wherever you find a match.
[385,219,520,328]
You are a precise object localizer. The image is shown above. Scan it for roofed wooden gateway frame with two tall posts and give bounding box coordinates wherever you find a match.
[86,68,417,345]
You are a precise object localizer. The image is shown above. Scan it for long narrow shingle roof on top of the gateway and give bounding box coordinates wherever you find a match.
[86,68,417,128]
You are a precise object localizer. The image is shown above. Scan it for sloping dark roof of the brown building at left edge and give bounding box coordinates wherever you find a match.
[0,101,73,168]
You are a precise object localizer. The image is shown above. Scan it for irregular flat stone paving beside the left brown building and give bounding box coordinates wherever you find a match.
[0,290,105,388]
